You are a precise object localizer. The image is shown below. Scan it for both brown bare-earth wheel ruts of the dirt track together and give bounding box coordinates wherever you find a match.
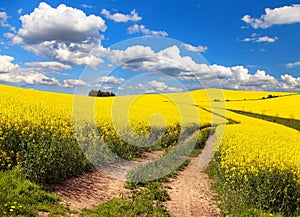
[54,136,220,217]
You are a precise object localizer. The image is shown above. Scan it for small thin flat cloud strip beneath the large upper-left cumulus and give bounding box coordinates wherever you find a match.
[24,61,72,72]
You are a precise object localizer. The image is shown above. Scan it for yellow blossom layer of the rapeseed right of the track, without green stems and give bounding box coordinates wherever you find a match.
[216,112,300,183]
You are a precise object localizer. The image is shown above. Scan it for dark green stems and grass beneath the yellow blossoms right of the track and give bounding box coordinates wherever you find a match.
[206,153,300,217]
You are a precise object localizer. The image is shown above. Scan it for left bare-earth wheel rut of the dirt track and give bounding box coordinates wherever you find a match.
[54,151,164,211]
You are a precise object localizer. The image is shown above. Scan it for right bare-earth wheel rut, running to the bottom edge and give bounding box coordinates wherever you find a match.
[165,136,220,217]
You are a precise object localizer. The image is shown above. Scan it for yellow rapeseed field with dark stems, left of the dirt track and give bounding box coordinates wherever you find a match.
[0,85,225,182]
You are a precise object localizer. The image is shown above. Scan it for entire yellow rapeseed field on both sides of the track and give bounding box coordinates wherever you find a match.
[0,85,300,214]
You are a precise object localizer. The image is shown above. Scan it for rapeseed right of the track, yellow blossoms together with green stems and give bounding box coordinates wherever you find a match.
[214,111,300,213]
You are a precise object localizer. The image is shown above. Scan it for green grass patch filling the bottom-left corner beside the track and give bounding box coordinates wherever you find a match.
[0,168,71,217]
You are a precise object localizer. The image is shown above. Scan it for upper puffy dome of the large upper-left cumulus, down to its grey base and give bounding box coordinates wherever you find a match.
[14,2,106,44]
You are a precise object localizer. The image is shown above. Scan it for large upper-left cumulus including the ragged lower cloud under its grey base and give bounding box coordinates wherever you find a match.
[12,2,107,67]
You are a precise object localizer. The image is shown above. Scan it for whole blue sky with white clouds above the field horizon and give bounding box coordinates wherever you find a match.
[0,0,300,94]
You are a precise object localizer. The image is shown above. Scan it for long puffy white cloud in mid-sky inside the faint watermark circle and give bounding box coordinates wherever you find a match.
[108,45,209,77]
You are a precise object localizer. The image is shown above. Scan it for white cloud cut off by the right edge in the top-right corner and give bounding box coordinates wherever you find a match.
[242,4,300,29]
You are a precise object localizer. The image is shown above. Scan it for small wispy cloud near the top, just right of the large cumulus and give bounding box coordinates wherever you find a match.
[101,9,142,23]
